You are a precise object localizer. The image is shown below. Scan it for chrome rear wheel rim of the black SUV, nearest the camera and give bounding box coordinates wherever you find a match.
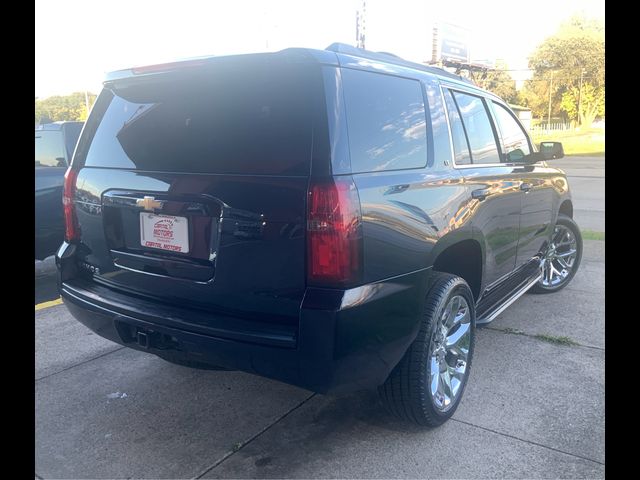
[428,295,471,412]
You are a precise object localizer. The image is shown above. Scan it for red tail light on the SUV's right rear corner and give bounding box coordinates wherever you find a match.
[307,177,362,286]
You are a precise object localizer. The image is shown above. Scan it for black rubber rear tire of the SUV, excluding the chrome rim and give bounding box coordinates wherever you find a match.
[378,272,476,427]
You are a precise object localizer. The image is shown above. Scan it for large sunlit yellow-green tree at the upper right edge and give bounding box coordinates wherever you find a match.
[529,16,605,125]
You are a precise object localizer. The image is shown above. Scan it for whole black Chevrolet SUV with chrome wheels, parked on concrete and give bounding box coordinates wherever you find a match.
[56,44,582,425]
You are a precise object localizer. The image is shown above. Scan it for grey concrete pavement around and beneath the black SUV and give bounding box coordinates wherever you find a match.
[35,157,605,478]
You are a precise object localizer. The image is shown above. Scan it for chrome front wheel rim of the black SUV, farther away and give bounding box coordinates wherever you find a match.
[540,225,578,288]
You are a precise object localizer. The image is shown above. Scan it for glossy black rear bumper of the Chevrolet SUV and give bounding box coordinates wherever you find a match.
[56,245,429,393]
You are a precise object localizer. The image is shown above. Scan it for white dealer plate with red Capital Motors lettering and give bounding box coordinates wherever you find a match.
[140,213,189,253]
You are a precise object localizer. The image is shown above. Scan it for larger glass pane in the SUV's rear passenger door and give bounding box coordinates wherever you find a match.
[452,92,500,163]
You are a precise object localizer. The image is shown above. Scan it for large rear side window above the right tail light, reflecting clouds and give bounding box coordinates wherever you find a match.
[342,69,427,173]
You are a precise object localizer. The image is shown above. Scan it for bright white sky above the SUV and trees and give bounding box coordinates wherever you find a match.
[35,0,604,99]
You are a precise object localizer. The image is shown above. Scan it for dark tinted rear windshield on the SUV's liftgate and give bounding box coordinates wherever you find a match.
[80,64,313,175]
